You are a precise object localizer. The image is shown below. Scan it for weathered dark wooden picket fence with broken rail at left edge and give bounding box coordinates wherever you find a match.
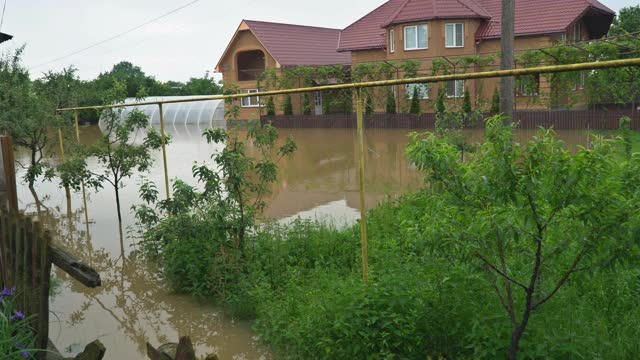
[0,136,104,359]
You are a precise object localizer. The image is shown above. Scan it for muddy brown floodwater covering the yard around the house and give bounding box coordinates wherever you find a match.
[12,126,588,360]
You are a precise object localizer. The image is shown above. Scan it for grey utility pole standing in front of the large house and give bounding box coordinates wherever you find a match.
[500,0,516,121]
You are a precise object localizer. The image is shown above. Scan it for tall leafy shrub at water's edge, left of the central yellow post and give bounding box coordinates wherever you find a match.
[134,118,296,300]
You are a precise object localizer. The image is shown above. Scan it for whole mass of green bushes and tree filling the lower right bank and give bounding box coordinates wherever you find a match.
[137,117,640,359]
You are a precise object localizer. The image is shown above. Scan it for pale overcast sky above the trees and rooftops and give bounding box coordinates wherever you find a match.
[0,0,640,81]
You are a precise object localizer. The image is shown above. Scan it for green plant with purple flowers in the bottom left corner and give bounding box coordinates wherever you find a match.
[0,288,37,359]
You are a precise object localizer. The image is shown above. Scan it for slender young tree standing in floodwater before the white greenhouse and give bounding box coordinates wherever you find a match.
[88,80,162,231]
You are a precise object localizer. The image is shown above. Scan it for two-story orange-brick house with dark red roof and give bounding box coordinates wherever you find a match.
[218,0,615,119]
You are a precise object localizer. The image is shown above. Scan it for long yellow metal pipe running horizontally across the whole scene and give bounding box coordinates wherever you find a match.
[58,58,640,111]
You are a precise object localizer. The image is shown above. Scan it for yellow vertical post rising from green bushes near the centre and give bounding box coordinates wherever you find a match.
[356,88,369,285]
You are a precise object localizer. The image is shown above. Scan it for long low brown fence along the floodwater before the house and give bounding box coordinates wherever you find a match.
[260,110,640,130]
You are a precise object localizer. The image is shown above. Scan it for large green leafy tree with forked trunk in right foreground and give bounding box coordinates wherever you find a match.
[407,116,640,360]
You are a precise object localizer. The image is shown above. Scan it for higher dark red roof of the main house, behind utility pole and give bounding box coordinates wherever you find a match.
[338,0,615,51]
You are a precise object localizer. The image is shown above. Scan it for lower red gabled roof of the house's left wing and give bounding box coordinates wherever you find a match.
[217,20,351,71]
